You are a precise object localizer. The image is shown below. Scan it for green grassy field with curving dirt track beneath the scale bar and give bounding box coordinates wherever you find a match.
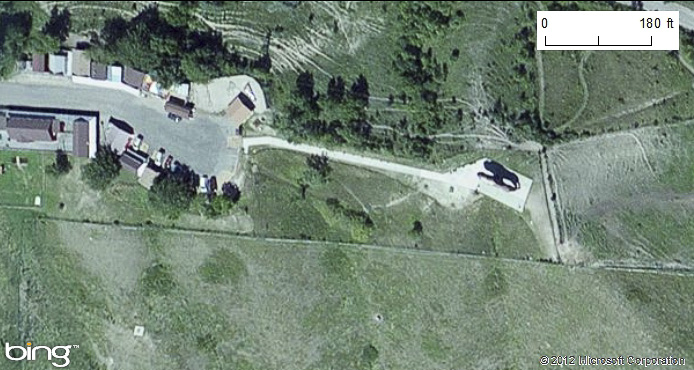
[543,51,694,134]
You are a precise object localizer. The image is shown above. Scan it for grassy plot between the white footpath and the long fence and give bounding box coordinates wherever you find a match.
[246,150,544,258]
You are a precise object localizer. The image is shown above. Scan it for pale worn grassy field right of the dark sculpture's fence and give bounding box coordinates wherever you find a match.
[550,122,694,264]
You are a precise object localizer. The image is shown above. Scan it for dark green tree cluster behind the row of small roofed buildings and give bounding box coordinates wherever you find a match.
[91,1,270,86]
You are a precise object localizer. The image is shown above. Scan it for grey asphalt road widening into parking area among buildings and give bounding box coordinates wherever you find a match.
[0,75,238,175]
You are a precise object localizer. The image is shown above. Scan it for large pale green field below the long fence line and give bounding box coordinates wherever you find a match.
[0,212,694,370]
